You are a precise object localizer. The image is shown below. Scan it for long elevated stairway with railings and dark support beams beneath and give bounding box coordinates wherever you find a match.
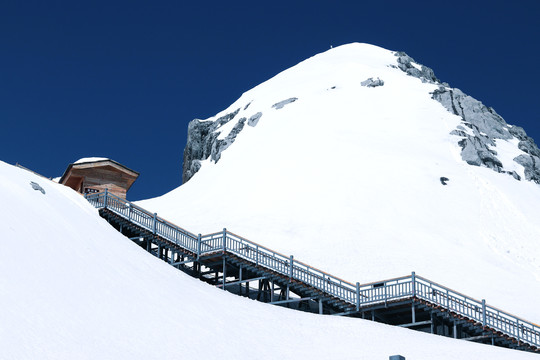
[86,191,540,352]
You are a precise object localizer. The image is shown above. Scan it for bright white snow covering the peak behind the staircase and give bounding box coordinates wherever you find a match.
[139,44,540,322]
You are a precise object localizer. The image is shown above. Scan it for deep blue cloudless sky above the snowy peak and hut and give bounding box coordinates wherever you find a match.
[0,0,540,200]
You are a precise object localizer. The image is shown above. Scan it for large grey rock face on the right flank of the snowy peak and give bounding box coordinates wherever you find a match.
[395,52,540,184]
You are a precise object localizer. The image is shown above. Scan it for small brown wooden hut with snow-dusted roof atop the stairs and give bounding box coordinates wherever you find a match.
[58,158,139,199]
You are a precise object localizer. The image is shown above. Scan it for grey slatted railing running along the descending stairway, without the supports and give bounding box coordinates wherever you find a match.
[85,190,540,348]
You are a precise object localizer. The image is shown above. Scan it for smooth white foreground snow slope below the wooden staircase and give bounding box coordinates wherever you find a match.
[0,162,537,360]
